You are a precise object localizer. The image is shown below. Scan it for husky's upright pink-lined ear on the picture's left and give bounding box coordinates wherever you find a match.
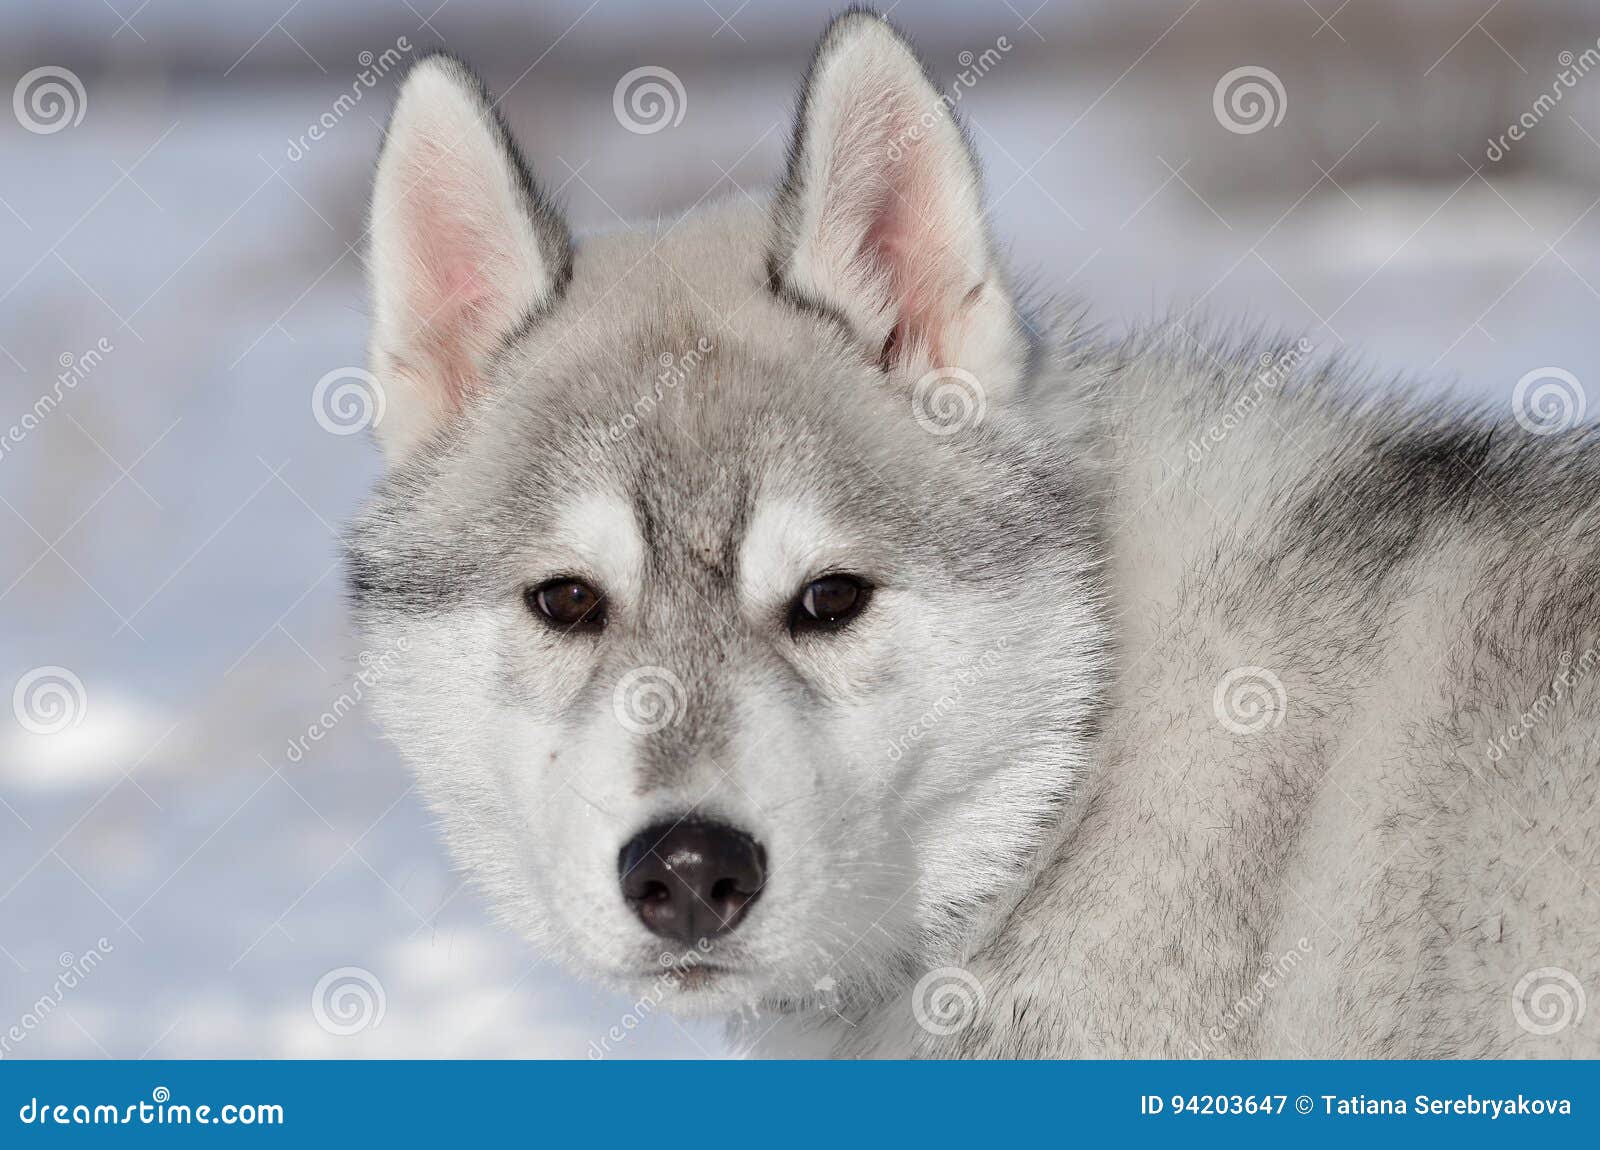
[368,54,573,461]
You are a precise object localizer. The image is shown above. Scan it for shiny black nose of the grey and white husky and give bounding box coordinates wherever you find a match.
[618,821,766,944]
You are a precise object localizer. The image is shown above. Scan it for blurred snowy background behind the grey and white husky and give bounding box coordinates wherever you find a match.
[0,0,1600,1057]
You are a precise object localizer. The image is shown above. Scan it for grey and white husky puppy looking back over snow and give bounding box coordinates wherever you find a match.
[349,11,1600,1057]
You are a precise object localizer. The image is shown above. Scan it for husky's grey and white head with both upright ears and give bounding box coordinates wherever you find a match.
[350,13,1104,1011]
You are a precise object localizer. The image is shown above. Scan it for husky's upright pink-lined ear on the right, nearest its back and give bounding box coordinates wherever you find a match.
[768,11,1029,398]
